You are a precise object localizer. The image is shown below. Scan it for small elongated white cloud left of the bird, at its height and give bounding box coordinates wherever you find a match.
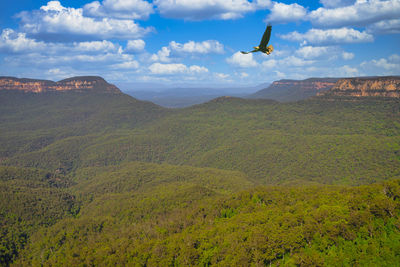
[169,40,224,54]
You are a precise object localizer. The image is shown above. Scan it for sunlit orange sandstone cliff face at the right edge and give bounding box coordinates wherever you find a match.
[318,76,400,97]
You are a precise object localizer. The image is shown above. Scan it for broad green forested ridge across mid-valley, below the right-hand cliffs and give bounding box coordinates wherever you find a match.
[3,98,400,184]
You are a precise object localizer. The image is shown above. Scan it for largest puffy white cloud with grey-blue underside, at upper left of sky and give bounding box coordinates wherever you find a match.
[18,1,152,41]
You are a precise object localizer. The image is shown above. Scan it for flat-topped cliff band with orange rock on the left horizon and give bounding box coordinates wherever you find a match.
[0,76,121,93]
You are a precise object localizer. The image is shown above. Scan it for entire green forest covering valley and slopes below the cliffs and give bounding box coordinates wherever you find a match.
[0,91,400,266]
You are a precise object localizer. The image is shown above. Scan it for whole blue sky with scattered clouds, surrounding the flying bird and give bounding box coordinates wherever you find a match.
[0,0,400,89]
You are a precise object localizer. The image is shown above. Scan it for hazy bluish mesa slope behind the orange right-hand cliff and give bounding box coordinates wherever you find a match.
[249,78,339,102]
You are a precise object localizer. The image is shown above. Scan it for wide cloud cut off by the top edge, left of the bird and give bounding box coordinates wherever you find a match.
[153,0,271,20]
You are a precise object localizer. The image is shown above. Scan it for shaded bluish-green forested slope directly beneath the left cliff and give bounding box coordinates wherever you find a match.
[0,90,168,164]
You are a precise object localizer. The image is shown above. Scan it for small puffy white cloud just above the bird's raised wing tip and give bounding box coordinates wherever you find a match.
[265,3,307,23]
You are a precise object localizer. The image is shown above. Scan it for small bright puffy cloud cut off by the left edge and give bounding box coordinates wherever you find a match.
[0,29,46,53]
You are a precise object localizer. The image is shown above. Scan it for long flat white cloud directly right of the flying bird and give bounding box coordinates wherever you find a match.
[280,28,374,45]
